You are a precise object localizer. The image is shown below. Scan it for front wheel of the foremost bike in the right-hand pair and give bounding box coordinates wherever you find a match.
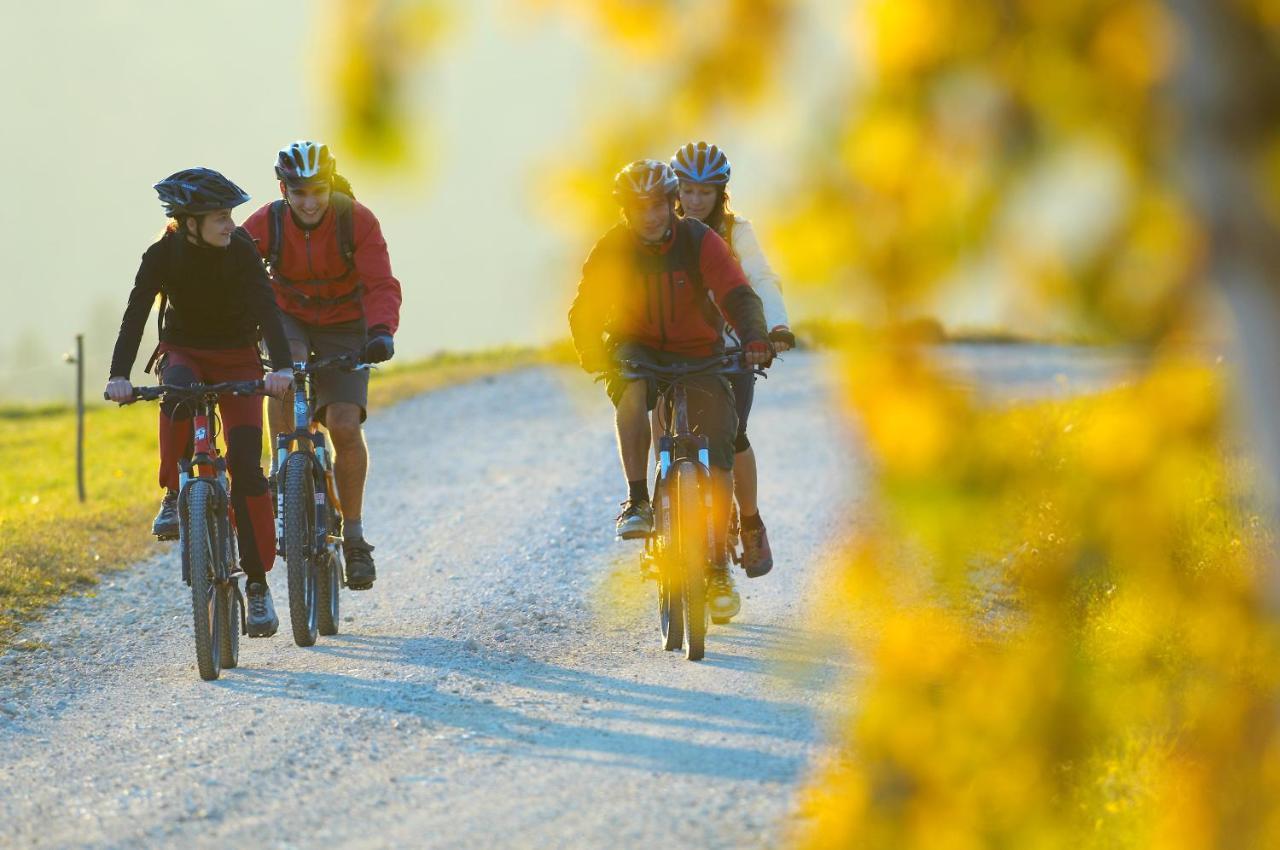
[671,461,708,661]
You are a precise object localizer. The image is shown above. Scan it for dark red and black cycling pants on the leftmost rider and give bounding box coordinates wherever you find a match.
[159,343,275,581]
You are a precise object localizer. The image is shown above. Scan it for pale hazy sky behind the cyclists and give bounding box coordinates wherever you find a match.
[0,0,855,398]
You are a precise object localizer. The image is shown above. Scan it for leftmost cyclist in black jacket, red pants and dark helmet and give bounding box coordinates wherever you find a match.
[106,168,293,638]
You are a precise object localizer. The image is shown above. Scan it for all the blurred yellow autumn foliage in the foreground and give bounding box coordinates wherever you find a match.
[322,0,1280,850]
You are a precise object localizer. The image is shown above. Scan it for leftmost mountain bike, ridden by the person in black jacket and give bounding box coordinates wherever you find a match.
[107,380,262,681]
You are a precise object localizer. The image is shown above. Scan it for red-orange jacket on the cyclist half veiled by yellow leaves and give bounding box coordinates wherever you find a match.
[568,213,767,371]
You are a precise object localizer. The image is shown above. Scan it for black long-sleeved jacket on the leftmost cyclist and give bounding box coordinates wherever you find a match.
[110,228,291,378]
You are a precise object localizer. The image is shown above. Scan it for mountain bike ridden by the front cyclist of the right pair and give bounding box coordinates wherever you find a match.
[620,348,764,661]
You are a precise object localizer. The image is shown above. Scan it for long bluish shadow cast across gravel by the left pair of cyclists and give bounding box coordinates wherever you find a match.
[218,635,814,781]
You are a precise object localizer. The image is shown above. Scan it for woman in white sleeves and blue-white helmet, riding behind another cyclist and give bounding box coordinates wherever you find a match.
[671,142,795,579]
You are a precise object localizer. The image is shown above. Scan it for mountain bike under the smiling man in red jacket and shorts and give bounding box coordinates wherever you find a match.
[271,352,371,646]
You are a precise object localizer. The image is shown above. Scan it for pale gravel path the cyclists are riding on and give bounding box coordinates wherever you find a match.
[0,347,1112,849]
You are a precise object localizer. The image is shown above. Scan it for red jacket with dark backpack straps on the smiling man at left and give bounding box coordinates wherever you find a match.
[243,201,401,334]
